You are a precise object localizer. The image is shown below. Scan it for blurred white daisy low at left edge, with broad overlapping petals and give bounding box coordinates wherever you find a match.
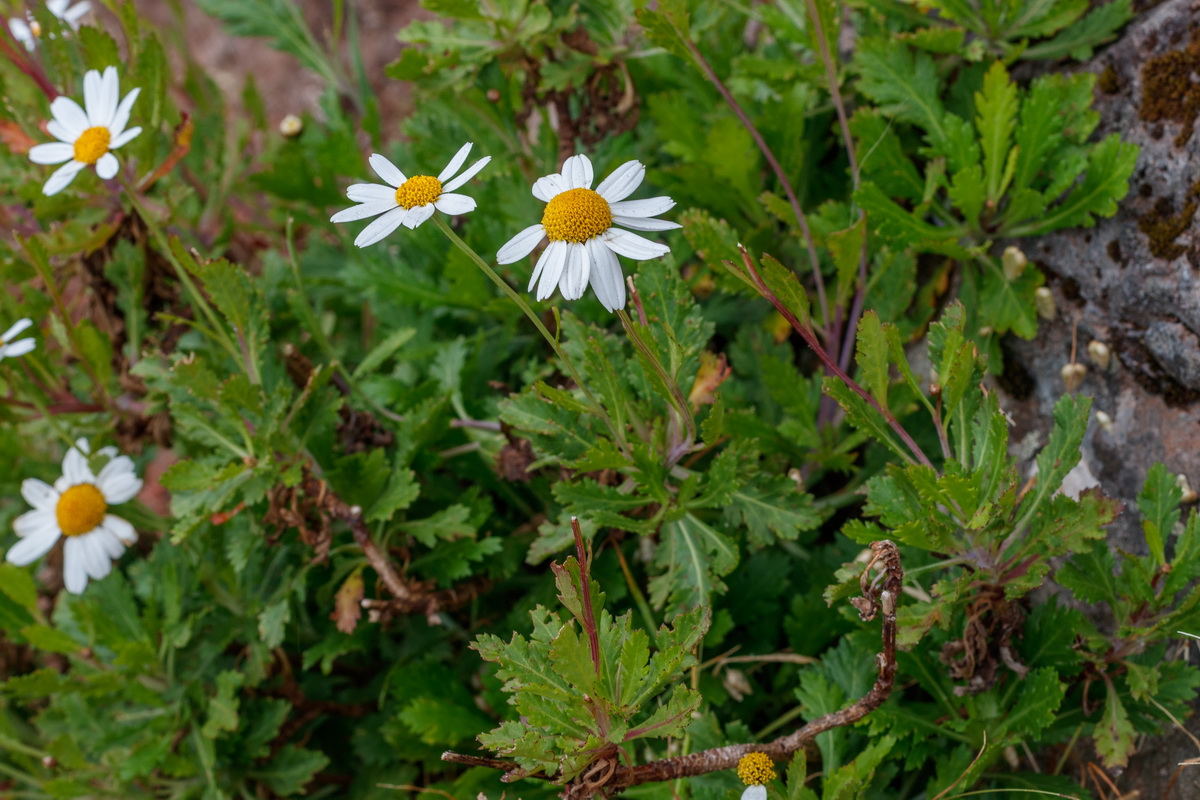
[5,439,142,595]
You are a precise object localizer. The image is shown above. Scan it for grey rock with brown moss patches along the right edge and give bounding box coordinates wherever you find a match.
[1001,0,1200,800]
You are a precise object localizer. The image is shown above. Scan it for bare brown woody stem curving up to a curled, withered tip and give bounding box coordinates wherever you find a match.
[442,540,904,798]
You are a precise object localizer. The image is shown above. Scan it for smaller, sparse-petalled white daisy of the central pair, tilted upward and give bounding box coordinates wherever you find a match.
[329,142,492,247]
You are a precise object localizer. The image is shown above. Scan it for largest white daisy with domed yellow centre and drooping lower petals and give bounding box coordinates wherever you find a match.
[496,155,679,311]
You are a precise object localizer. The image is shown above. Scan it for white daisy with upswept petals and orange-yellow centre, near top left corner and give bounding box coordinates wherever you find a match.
[29,67,142,194]
